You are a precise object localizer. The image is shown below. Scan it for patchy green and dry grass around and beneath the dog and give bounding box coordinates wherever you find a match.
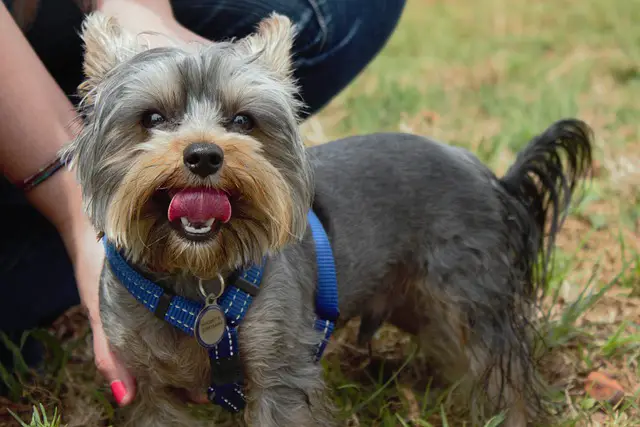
[0,0,640,427]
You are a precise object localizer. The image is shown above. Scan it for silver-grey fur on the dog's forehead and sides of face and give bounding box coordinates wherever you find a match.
[64,43,311,251]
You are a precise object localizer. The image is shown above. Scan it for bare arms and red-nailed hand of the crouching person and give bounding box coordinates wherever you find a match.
[0,0,210,405]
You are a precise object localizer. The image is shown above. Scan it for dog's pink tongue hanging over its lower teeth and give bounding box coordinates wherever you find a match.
[167,188,231,223]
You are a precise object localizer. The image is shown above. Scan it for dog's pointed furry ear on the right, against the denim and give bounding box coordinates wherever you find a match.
[238,13,295,77]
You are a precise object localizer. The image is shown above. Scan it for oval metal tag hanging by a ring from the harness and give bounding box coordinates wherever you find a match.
[193,276,227,349]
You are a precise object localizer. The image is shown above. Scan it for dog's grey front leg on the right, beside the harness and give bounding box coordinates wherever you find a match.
[240,270,336,427]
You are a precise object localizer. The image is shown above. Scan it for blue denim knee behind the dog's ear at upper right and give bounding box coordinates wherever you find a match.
[172,0,405,114]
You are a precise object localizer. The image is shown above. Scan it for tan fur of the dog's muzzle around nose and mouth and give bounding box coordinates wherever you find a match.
[105,132,294,278]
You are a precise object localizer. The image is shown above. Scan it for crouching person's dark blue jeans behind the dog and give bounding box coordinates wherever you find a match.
[0,0,404,362]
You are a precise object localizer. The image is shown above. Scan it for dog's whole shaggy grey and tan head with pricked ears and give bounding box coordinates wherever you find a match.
[63,14,312,278]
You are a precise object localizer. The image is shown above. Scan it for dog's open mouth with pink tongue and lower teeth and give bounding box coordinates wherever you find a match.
[156,187,231,242]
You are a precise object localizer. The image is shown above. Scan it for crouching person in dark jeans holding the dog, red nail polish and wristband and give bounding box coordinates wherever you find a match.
[0,0,404,405]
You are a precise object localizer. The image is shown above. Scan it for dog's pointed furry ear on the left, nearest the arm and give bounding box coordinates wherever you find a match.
[78,12,142,97]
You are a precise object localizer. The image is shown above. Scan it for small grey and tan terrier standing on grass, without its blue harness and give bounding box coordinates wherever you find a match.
[61,14,593,427]
